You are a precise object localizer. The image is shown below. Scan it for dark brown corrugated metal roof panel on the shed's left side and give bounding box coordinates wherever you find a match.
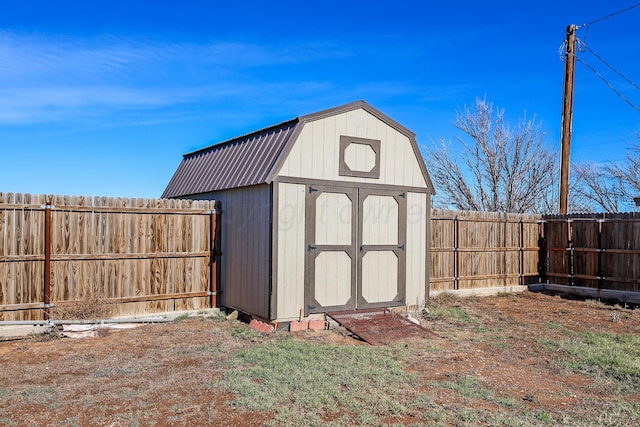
[162,119,299,198]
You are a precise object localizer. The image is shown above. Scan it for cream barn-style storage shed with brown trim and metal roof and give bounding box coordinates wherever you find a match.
[162,101,434,321]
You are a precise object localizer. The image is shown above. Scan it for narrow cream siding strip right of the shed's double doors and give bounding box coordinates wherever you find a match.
[406,193,430,307]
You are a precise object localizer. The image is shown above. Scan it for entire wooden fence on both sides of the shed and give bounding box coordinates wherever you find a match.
[0,193,640,320]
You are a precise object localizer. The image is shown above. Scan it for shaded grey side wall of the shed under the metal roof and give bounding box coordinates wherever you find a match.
[213,185,271,319]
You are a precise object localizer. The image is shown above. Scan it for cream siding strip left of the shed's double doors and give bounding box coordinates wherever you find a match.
[273,183,306,319]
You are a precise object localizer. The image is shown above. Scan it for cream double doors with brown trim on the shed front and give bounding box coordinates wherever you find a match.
[305,185,407,314]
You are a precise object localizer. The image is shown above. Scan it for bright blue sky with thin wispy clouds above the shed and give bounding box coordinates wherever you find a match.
[0,0,640,197]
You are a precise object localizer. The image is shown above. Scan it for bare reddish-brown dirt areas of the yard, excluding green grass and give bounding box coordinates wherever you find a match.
[0,292,640,426]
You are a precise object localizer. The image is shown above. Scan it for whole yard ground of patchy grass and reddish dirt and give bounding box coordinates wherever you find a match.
[0,293,640,427]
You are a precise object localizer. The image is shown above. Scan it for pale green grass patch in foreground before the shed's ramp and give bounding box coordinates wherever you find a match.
[208,338,413,425]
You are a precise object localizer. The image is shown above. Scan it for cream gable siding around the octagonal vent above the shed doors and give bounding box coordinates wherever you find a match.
[278,109,427,188]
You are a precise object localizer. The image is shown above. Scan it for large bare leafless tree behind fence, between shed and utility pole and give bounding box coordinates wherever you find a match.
[425,98,557,216]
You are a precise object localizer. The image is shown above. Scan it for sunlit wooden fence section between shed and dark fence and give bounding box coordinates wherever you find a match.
[429,209,541,292]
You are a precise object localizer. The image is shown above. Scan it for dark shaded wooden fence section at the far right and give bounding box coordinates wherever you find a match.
[541,213,640,292]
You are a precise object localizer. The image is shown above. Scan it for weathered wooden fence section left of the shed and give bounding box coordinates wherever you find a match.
[0,193,219,320]
